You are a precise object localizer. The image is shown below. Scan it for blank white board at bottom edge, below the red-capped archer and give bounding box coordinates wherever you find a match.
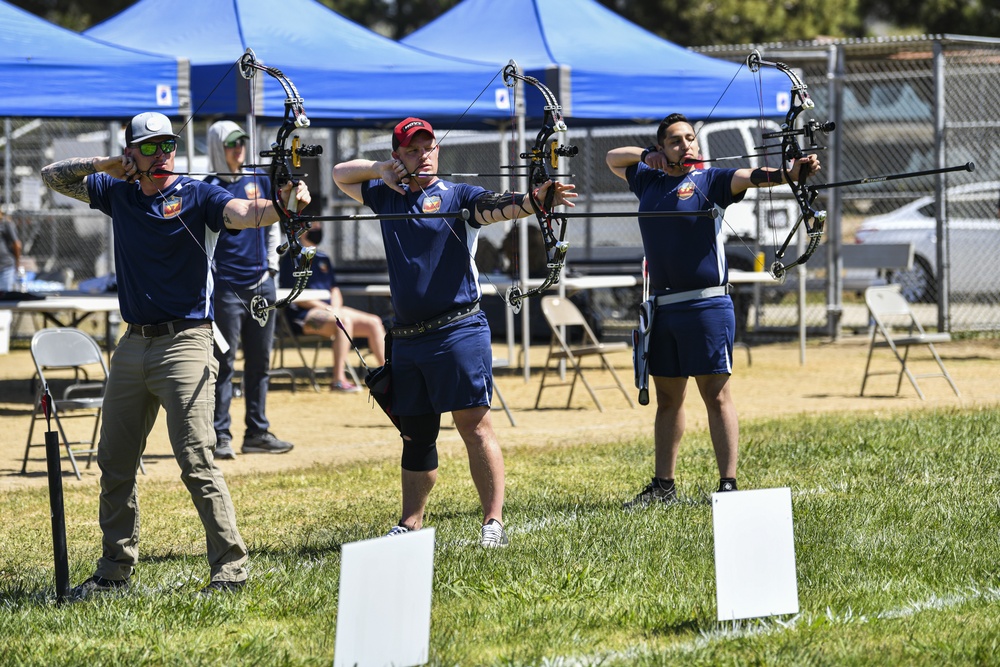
[333,528,434,667]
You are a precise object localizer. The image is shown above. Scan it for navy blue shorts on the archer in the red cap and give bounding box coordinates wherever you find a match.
[391,312,493,417]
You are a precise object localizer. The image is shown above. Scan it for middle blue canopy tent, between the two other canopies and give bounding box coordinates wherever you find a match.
[85,0,510,126]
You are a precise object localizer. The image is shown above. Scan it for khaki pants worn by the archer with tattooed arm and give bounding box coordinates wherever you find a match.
[95,328,247,581]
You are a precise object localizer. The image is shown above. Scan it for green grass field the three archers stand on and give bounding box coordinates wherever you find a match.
[0,409,1000,666]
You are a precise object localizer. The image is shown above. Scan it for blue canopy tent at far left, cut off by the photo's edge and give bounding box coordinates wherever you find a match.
[0,2,189,119]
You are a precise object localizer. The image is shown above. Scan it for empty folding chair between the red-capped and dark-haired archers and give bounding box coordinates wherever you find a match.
[535,296,635,412]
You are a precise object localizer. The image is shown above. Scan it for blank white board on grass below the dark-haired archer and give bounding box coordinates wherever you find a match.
[712,487,799,621]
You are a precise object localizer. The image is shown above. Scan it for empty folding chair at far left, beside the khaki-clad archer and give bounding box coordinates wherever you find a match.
[21,328,146,479]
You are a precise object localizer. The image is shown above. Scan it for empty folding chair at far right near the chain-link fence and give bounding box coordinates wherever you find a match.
[860,285,961,400]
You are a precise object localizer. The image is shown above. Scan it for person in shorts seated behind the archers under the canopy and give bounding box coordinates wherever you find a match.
[279,222,385,392]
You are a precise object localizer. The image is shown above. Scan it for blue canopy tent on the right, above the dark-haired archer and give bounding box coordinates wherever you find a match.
[401,0,789,124]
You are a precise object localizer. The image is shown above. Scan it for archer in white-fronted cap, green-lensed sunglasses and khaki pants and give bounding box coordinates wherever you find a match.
[42,112,309,598]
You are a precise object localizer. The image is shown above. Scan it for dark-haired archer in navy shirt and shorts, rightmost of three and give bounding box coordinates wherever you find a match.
[607,114,820,509]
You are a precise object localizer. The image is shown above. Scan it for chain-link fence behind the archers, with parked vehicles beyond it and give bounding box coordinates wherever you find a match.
[0,37,1000,336]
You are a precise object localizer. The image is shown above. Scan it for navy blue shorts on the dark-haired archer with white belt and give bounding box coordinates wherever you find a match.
[649,295,736,377]
